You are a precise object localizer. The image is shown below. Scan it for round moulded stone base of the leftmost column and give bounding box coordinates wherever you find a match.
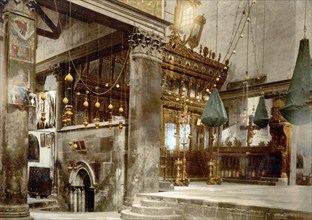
[0,205,33,220]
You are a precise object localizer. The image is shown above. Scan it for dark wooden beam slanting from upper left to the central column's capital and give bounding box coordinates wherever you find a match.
[36,0,133,33]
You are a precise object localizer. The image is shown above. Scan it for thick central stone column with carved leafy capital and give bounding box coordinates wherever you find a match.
[126,29,165,205]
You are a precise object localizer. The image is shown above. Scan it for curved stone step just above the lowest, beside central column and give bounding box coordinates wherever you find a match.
[131,204,174,215]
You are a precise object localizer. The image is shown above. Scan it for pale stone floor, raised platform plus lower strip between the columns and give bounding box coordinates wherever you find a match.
[31,182,312,220]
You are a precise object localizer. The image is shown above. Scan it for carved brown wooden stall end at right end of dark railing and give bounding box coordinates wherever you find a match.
[269,98,292,178]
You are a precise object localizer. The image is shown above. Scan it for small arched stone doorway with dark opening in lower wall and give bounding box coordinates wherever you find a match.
[69,161,95,212]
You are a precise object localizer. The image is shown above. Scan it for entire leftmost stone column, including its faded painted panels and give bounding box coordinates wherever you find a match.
[0,0,35,220]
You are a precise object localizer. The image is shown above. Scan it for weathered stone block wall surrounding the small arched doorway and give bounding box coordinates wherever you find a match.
[56,122,127,211]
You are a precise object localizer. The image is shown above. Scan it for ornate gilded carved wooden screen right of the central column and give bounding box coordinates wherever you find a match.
[160,21,228,180]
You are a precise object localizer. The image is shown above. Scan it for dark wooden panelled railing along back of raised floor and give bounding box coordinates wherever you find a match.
[160,147,281,180]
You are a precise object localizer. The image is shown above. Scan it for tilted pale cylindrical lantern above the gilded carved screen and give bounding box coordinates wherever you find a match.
[187,15,206,50]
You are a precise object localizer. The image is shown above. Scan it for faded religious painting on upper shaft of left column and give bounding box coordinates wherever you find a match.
[8,12,36,105]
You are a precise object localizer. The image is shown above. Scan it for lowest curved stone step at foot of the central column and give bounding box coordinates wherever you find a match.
[121,209,182,220]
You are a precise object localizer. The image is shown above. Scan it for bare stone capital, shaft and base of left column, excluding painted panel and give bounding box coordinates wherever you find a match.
[0,0,33,220]
